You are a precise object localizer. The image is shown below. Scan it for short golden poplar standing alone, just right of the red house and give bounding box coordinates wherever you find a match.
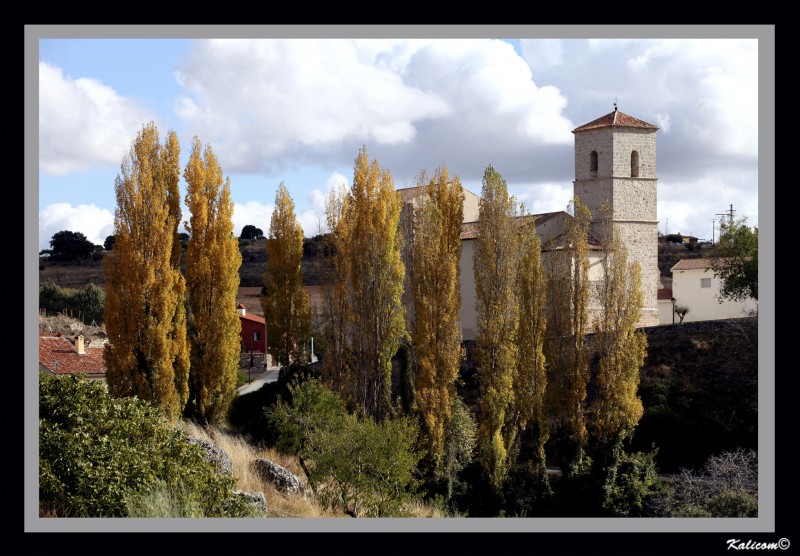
[261,182,311,365]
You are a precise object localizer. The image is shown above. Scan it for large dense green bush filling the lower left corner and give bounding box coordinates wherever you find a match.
[39,374,252,517]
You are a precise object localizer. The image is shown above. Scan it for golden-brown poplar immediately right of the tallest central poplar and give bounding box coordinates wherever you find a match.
[409,165,464,472]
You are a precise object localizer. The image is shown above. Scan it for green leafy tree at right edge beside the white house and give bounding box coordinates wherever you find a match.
[710,218,758,303]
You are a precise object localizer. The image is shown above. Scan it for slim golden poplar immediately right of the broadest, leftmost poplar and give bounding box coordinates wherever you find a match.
[183,137,242,422]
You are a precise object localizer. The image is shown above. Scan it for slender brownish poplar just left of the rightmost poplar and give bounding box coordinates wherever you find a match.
[544,198,591,476]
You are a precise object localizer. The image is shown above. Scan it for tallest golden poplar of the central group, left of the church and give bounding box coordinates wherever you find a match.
[341,147,406,420]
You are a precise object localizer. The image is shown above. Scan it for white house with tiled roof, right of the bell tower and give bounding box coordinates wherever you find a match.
[660,259,758,324]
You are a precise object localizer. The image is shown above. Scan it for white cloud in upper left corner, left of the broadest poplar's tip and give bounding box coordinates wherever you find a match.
[39,61,155,175]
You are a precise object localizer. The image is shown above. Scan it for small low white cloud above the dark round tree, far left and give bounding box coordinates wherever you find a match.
[39,203,114,250]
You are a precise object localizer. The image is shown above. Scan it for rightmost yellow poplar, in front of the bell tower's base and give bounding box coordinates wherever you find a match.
[590,207,647,475]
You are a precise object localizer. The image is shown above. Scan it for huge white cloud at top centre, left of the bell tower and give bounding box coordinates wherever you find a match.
[175,39,573,178]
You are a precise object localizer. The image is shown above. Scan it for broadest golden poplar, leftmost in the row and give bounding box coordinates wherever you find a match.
[103,122,190,418]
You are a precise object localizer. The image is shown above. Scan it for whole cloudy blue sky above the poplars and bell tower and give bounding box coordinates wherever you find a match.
[38,34,774,249]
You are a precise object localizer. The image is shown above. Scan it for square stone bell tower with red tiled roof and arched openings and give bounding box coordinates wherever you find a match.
[572,103,660,326]
